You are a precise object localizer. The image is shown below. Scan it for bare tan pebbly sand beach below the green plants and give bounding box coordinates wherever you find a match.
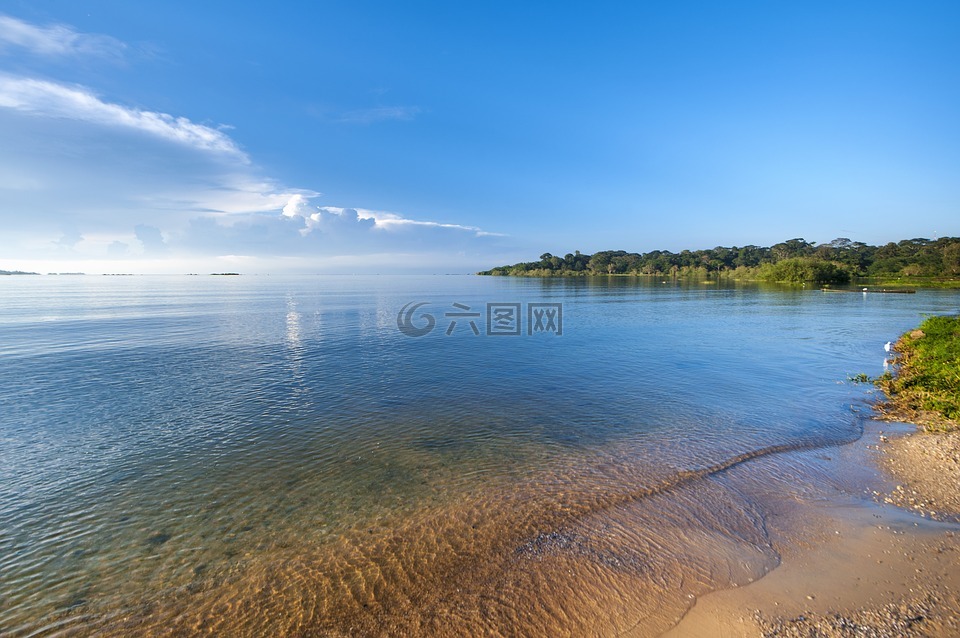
[664,424,960,638]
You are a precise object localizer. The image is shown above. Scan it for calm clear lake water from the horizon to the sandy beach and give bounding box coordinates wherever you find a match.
[0,276,960,635]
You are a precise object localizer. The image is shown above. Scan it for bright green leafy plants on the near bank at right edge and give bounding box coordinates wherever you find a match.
[874,317,960,431]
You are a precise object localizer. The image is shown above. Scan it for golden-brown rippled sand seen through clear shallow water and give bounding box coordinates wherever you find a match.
[26,432,864,636]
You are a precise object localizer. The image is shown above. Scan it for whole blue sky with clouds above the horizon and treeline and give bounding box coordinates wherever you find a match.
[0,0,960,273]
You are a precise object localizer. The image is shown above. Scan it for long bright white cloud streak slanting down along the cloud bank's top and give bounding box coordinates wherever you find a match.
[0,75,247,162]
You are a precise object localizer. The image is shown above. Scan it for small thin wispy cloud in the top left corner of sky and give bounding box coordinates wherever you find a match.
[0,15,126,57]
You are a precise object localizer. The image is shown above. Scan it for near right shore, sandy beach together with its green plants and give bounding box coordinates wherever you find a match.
[663,316,960,638]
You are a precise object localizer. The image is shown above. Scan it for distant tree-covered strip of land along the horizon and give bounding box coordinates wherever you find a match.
[477,237,960,285]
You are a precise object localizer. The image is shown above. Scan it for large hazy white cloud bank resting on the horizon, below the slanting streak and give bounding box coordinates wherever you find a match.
[0,91,510,272]
